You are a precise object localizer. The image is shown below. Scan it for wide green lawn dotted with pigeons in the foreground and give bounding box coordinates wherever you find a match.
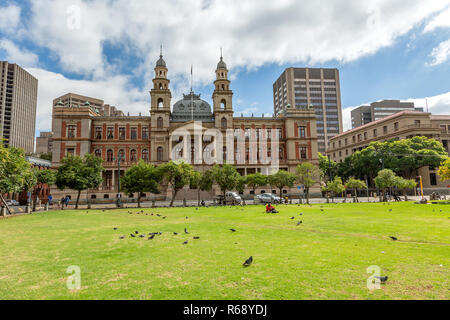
[0,203,450,300]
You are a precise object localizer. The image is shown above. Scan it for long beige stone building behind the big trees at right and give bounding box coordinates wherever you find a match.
[327,111,450,190]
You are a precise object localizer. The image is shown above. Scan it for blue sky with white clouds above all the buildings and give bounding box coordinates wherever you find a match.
[0,0,450,135]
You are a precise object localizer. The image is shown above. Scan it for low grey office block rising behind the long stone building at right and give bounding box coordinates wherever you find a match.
[351,100,423,128]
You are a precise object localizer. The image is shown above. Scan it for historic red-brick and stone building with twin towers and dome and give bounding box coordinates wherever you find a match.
[52,55,318,199]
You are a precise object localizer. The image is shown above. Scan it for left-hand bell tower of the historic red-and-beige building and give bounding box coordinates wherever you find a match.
[150,46,172,162]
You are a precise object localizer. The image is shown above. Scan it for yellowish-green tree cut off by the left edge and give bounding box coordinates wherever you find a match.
[0,145,31,214]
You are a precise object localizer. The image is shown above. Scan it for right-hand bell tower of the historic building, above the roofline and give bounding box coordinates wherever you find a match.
[212,54,233,129]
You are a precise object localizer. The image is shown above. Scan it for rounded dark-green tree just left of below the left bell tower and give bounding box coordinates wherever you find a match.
[121,160,162,208]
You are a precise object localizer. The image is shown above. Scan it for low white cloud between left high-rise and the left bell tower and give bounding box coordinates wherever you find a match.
[27,68,150,131]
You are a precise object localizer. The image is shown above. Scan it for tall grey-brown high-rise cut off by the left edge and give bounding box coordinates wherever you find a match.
[0,61,38,154]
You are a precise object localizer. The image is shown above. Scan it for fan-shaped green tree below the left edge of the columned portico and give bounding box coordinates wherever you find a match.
[159,161,193,207]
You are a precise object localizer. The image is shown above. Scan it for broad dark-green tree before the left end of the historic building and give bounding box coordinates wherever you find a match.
[56,154,104,209]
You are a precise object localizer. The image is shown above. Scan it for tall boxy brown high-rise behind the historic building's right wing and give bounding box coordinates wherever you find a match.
[273,68,343,154]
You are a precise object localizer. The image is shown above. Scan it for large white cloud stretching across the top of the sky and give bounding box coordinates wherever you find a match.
[29,0,449,84]
